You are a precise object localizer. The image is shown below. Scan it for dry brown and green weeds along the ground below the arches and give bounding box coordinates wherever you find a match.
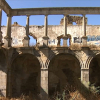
[0,84,100,100]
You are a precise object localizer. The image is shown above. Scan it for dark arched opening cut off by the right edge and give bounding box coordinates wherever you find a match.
[89,54,100,87]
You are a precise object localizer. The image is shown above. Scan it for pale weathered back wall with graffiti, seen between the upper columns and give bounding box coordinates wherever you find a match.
[1,25,100,46]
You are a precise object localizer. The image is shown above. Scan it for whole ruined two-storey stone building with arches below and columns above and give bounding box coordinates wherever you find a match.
[0,0,100,100]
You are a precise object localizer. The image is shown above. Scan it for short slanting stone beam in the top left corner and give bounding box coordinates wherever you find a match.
[0,0,11,15]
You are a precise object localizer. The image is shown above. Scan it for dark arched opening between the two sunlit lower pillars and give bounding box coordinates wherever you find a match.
[48,54,80,97]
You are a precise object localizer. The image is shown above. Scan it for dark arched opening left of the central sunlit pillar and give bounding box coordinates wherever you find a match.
[11,54,40,98]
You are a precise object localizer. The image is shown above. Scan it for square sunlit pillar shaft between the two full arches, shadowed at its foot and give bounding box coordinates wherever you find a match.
[41,69,48,100]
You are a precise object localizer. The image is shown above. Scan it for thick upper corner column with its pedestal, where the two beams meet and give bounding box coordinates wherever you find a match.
[4,15,12,47]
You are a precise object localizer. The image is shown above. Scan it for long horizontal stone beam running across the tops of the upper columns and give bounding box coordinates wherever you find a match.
[11,7,100,16]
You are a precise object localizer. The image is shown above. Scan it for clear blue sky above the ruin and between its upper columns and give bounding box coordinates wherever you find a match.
[2,0,100,44]
